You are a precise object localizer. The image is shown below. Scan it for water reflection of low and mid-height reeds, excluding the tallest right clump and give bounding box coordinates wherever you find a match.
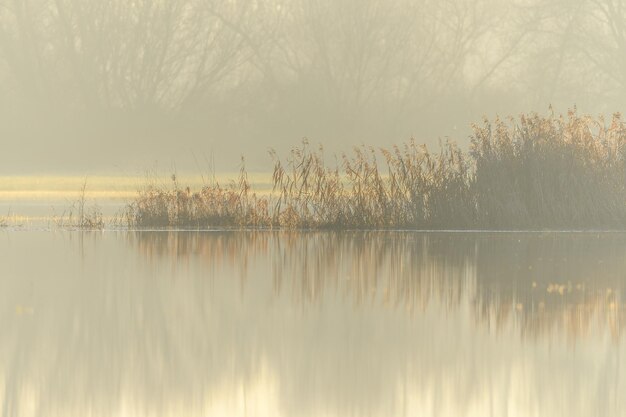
[131,232,474,310]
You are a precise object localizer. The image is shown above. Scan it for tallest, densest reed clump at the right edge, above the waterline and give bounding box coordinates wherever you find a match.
[469,111,626,229]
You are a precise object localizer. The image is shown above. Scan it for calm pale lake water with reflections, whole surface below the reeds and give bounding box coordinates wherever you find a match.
[0,230,626,417]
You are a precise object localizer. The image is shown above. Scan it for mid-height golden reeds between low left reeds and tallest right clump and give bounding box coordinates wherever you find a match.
[273,140,472,229]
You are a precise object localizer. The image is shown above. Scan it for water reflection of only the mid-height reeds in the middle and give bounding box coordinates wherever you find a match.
[272,232,473,311]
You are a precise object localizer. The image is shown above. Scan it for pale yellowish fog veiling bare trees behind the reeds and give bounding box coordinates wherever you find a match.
[0,0,626,174]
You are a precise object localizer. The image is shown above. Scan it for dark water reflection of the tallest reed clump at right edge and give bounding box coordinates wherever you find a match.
[476,233,626,341]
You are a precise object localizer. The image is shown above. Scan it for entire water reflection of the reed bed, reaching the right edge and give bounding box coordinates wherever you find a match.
[130,232,626,340]
